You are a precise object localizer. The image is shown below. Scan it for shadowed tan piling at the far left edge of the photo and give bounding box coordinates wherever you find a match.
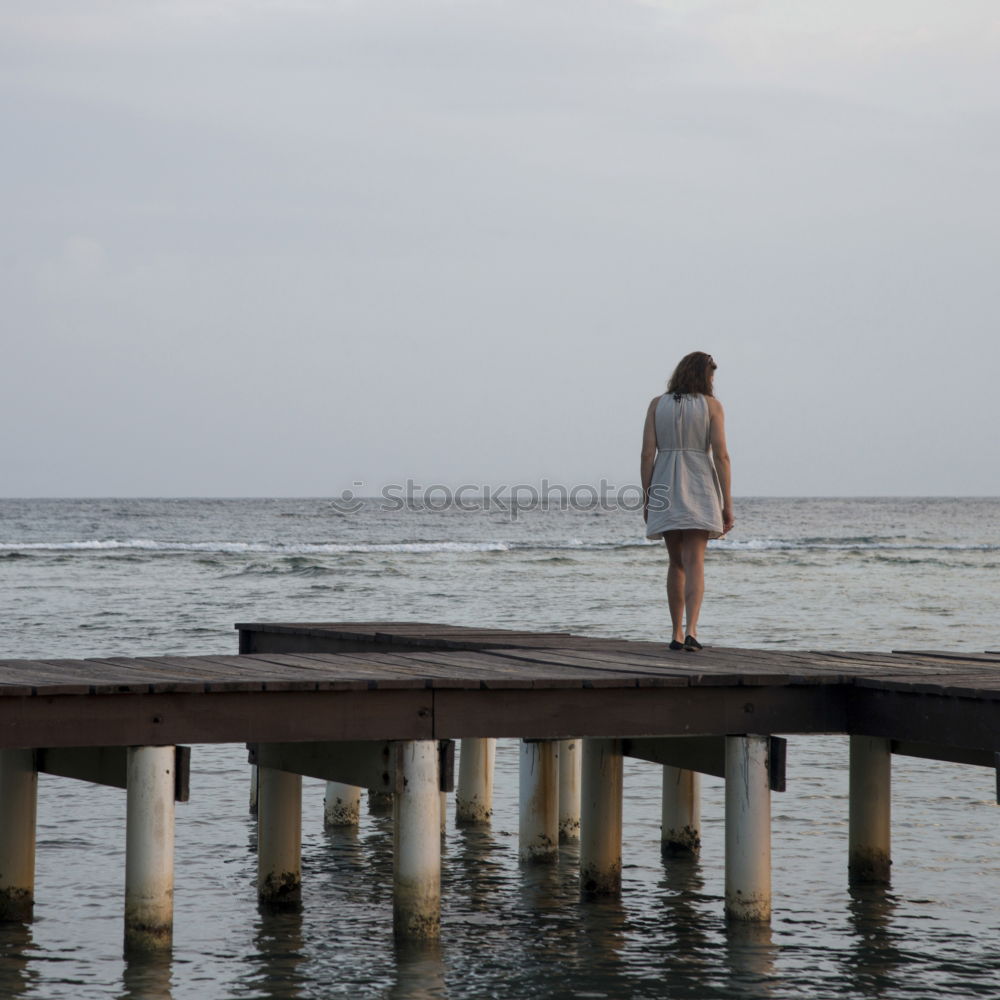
[0,750,38,921]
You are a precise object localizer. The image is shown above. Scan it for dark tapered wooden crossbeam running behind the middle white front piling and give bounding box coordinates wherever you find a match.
[247,740,455,792]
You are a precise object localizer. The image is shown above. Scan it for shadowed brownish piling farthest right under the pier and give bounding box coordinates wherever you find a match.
[847,736,892,883]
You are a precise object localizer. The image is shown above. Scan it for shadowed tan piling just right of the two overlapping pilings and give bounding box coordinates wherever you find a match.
[580,739,622,896]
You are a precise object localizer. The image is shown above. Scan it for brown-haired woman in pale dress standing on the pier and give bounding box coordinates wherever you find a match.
[641,351,734,651]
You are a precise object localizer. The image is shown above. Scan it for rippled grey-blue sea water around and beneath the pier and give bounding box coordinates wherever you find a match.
[0,498,1000,1000]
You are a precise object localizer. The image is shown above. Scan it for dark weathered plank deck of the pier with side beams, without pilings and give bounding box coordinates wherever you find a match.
[0,622,1000,766]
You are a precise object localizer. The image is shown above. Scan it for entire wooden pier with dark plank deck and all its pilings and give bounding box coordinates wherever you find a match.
[0,622,1000,949]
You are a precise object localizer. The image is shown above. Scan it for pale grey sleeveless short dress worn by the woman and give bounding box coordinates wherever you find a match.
[646,393,722,538]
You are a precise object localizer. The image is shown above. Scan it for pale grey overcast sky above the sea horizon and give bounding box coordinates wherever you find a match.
[0,0,1000,496]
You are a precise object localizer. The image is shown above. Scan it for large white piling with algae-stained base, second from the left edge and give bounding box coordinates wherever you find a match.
[125,746,176,952]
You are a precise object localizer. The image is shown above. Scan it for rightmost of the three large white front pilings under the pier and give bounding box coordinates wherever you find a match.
[725,736,771,921]
